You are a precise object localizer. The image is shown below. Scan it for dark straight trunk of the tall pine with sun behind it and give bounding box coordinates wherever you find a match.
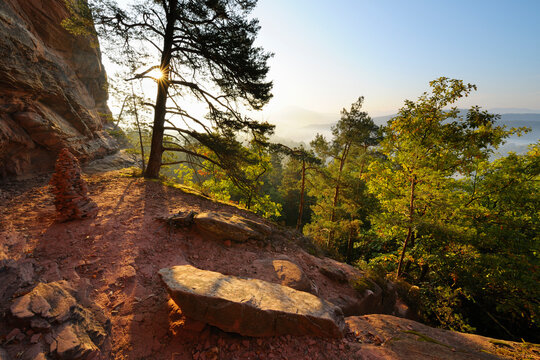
[144,0,178,179]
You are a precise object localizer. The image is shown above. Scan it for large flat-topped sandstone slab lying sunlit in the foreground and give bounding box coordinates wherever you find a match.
[159,265,345,337]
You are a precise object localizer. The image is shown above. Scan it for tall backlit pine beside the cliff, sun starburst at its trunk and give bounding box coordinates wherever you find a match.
[64,0,273,181]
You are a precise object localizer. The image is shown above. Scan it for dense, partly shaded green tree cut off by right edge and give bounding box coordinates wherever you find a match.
[449,143,540,342]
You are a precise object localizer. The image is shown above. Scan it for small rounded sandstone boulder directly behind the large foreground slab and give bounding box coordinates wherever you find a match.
[252,259,311,292]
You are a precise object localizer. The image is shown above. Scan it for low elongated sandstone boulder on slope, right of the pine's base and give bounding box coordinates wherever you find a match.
[193,212,272,242]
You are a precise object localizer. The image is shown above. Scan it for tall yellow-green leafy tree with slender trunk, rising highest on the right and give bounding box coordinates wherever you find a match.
[370,77,512,277]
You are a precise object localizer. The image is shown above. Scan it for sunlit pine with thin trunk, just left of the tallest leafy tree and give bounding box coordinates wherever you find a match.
[307,97,378,259]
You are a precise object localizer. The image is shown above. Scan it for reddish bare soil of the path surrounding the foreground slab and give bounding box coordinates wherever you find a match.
[0,172,368,359]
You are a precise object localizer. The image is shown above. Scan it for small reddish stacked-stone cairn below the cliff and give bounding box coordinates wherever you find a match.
[51,149,97,221]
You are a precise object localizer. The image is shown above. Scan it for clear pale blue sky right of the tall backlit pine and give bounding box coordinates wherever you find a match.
[253,0,540,124]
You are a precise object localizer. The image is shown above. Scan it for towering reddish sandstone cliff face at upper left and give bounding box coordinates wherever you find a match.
[0,0,117,180]
